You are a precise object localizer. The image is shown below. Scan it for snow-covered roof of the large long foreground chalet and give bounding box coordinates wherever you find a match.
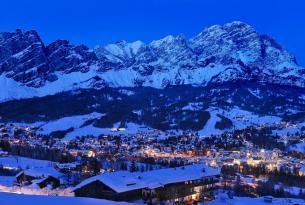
[73,164,220,193]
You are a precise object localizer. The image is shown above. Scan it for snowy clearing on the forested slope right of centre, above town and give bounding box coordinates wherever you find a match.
[199,107,282,136]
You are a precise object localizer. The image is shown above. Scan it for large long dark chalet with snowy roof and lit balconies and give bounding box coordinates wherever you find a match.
[73,164,220,203]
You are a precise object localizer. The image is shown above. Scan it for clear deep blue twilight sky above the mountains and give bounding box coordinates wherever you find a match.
[0,0,305,65]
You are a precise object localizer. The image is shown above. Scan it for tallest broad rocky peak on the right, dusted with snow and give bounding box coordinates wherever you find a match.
[190,21,296,69]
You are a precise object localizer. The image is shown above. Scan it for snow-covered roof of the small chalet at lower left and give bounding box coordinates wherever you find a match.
[16,167,63,178]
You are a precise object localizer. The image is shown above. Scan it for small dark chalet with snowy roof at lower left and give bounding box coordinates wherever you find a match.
[16,167,64,189]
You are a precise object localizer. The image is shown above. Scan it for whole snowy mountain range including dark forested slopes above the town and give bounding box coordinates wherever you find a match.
[0,21,305,136]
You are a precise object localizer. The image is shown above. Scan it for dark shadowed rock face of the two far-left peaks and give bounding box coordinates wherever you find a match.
[0,30,97,87]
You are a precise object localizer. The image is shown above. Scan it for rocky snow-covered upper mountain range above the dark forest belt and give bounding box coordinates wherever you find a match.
[0,21,305,102]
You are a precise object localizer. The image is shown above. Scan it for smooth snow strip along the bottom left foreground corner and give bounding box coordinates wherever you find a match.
[0,192,129,205]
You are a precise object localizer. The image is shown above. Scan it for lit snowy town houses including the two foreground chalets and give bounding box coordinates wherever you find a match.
[0,122,305,203]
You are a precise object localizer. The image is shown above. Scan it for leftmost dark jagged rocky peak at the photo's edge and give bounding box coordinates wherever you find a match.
[0,29,50,87]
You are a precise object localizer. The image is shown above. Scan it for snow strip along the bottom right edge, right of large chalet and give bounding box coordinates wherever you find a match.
[204,197,305,205]
